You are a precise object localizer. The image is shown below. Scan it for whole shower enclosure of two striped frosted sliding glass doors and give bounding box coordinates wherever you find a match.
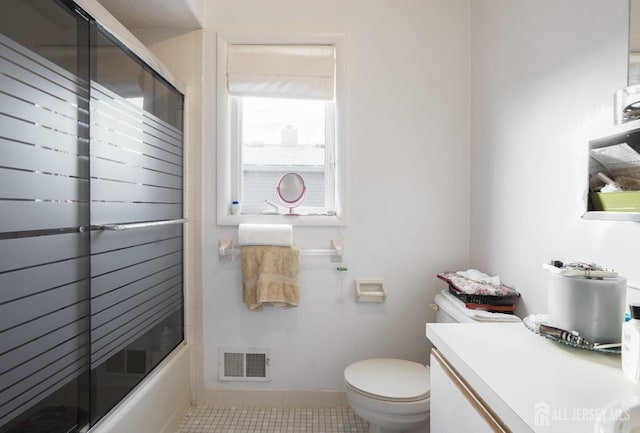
[0,0,184,433]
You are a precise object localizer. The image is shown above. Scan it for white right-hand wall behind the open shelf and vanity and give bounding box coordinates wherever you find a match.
[470,0,640,314]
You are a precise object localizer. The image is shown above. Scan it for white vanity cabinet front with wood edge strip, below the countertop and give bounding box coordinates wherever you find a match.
[431,349,511,433]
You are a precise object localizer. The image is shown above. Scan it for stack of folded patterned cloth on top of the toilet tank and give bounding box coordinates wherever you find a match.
[438,269,520,313]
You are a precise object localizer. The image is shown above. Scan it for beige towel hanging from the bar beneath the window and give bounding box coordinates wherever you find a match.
[240,245,300,311]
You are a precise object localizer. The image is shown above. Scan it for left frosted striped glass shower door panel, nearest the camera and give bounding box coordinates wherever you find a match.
[0,0,90,433]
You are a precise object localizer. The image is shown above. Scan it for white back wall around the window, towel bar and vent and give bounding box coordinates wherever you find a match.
[199,0,469,393]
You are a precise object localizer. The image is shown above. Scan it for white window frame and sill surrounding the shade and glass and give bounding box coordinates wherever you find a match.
[216,33,346,226]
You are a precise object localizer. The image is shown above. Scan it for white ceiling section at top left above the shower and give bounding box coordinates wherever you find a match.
[98,0,202,30]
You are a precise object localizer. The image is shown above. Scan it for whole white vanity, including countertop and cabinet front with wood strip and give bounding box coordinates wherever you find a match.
[426,323,640,433]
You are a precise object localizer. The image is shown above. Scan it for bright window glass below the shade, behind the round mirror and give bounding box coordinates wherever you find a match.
[232,96,335,215]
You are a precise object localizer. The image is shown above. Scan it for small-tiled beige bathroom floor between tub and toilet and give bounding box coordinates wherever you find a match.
[177,407,369,433]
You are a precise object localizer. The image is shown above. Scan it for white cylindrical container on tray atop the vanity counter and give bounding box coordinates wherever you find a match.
[548,273,627,343]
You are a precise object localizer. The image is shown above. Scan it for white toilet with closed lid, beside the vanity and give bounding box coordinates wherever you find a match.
[344,290,520,433]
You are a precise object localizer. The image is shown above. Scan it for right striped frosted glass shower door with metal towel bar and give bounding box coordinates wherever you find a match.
[90,26,183,419]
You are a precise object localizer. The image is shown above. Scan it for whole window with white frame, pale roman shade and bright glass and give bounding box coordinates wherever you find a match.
[218,36,344,225]
